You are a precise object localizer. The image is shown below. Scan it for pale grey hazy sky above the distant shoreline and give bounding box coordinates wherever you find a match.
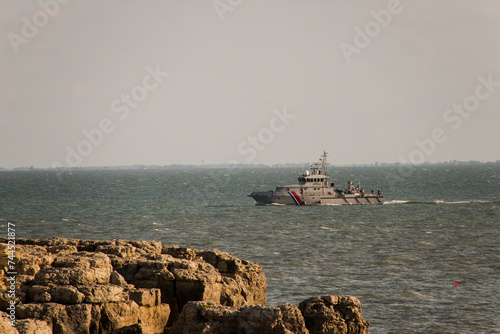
[0,0,500,168]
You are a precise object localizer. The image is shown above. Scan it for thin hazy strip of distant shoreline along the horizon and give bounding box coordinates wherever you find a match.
[0,160,500,172]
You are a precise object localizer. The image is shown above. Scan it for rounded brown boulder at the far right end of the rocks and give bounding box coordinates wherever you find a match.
[299,296,370,334]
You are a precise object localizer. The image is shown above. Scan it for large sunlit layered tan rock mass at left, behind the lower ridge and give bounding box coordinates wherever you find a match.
[0,238,266,333]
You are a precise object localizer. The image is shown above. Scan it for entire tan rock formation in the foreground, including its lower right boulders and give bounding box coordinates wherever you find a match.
[0,238,369,333]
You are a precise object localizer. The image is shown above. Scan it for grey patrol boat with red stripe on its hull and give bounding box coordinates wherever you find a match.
[248,151,384,205]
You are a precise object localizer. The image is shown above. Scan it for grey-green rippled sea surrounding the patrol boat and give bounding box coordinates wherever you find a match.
[0,166,500,333]
